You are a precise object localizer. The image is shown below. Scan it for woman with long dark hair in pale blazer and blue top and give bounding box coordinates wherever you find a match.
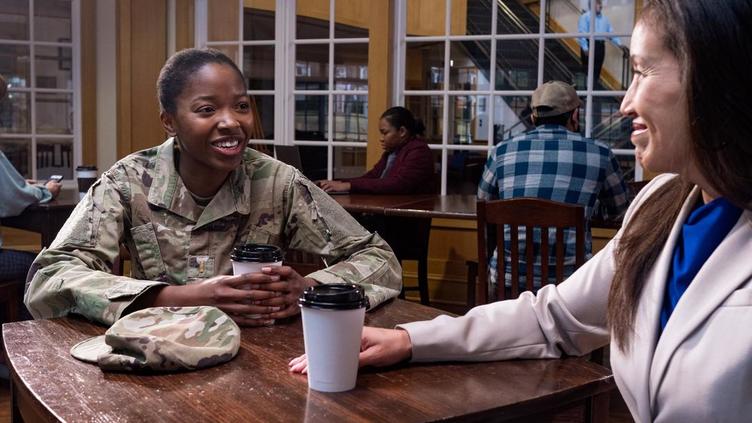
[291,0,752,422]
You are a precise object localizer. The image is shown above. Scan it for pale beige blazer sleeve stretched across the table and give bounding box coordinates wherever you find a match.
[398,177,670,361]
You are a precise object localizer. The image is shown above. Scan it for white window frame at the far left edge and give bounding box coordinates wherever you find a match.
[0,0,82,184]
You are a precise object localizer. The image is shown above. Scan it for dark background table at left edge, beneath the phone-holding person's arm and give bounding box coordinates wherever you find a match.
[0,190,79,247]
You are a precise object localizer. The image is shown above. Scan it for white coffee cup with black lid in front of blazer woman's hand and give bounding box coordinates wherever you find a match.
[299,284,368,392]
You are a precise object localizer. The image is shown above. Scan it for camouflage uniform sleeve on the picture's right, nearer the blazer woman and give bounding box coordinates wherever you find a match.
[285,172,402,307]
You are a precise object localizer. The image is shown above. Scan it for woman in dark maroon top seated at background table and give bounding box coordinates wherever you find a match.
[319,107,435,194]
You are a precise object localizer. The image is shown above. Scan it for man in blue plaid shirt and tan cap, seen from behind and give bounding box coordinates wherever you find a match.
[478,81,628,288]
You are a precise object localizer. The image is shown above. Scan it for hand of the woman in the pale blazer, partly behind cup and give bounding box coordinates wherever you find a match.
[288,326,413,374]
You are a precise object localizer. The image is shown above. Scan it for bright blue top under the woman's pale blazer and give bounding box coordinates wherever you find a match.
[661,197,742,331]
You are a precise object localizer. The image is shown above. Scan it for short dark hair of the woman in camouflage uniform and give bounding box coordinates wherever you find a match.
[157,48,248,114]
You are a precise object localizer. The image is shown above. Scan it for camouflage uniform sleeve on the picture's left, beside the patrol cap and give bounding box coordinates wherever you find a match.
[24,169,164,325]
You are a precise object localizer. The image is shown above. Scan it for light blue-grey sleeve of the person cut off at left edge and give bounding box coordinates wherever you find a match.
[0,152,52,217]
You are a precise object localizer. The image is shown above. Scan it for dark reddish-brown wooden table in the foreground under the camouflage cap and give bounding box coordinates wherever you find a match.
[3,300,615,422]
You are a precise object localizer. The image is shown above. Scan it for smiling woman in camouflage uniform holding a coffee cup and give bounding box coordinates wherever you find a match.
[26,49,401,326]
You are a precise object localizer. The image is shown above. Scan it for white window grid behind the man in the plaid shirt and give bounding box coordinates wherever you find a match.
[393,0,642,195]
